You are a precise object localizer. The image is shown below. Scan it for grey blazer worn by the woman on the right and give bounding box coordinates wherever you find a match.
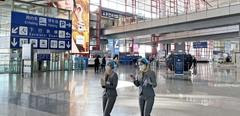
[134,70,157,97]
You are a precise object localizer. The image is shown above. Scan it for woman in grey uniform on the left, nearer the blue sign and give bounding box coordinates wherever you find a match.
[101,61,118,116]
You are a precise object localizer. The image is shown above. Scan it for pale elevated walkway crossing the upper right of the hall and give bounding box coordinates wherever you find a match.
[104,5,240,38]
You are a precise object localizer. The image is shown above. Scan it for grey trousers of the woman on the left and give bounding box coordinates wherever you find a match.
[103,96,117,116]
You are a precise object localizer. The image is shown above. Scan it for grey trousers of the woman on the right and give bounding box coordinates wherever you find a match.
[139,96,154,116]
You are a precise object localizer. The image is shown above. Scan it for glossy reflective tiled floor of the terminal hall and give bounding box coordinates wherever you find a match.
[0,64,240,116]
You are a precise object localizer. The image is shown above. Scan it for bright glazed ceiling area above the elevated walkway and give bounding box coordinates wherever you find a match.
[90,0,240,18]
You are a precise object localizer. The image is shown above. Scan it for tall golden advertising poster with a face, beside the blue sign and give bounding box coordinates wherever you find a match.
[53,0,89,53]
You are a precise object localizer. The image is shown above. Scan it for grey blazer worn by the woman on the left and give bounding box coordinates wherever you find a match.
[102,72,118,97]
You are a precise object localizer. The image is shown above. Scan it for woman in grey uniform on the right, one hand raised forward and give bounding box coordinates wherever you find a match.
[130,58,157,116]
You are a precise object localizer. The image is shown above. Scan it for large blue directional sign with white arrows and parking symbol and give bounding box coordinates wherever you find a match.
[10,12,72,50]
